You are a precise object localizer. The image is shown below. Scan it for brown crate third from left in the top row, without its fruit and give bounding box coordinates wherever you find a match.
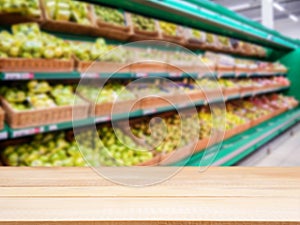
[91,6,131,41]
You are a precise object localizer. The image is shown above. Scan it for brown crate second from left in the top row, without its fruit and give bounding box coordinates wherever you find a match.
[40,0,96,35]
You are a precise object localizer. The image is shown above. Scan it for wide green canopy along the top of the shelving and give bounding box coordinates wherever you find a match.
[86,0,299,51]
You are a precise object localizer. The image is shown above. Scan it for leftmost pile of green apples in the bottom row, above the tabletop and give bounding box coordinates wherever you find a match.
[2,133,86,166]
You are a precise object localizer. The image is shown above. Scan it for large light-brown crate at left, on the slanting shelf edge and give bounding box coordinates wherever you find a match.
[1,98,89,129]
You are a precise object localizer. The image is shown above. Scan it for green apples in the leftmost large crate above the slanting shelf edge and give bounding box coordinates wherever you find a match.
[0,80,74,111]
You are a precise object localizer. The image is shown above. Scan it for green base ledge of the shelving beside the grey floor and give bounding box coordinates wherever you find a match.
[174,108,300,166]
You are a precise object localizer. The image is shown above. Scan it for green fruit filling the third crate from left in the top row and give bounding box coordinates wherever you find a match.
[94,5,125,26]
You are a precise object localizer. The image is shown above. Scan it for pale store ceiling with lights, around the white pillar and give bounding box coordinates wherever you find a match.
[212,0,300,21]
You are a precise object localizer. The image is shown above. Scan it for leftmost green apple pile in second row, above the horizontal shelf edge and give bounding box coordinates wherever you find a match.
[0,23,72,60]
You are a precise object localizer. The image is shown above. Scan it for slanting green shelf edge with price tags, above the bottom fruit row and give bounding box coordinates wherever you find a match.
[0,87,288,140]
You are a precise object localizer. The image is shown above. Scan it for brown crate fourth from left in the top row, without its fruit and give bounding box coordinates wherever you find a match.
[126,13,159,41]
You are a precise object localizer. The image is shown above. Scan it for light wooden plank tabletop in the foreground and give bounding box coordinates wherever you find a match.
[0,167,300,225]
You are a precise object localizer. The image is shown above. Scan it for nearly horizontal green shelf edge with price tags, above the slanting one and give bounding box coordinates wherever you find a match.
[0,71,285,81]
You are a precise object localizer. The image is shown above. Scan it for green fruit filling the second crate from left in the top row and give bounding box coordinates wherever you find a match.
[44,0,91,25]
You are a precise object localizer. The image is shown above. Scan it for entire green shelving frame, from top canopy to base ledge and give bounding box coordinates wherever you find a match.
[0,0,300,166]
